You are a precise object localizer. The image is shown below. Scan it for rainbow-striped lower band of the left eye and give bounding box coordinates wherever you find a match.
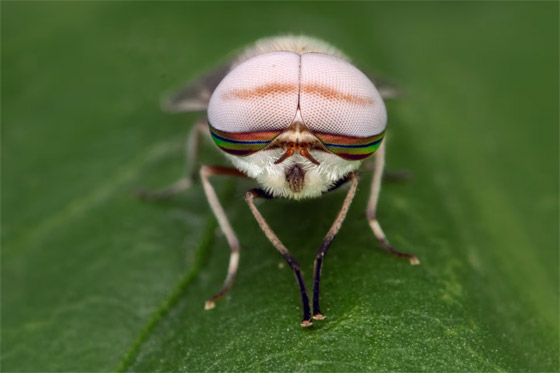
[208,125,282,157]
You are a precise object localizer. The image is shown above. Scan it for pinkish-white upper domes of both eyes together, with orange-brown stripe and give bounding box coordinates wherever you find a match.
[208,51,387,137]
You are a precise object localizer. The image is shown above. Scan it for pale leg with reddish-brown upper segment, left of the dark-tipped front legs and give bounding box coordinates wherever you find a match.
[200,165,247,310]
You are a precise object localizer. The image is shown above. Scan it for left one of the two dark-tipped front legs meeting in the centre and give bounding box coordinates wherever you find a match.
[245,189,313,327]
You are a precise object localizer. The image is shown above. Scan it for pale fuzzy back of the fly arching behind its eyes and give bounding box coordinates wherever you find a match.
[231,35,350,69]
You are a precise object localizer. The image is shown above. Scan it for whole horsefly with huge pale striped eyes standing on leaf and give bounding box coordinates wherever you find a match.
[139,36,419,327]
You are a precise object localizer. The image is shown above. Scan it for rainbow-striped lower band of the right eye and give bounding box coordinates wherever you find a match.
[314,131,385,161]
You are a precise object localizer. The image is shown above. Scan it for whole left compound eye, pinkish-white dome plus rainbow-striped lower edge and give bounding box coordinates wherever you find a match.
[208,52,299,155]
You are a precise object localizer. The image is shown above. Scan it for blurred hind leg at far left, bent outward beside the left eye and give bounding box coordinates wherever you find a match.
[134,119,207,200]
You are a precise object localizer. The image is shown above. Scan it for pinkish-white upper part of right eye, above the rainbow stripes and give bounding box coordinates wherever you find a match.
[300,53,387,138]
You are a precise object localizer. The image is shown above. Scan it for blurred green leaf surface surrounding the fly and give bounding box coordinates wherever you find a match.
[1,1,559,372]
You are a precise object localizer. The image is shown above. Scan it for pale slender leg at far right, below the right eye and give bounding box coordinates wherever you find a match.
[366,141,420,265]
